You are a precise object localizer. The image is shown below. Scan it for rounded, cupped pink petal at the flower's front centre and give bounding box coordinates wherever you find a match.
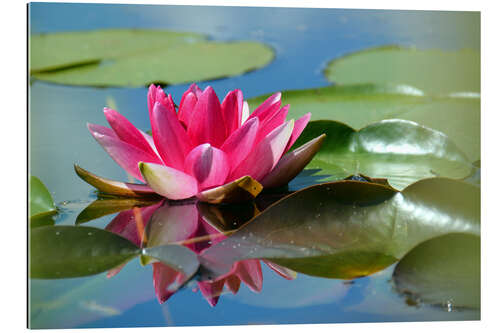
[185,143,229,190]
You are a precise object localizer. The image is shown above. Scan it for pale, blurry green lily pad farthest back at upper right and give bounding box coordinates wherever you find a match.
[324,46,481,95]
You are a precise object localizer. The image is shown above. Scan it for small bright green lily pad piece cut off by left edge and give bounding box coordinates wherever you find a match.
[29,176,57,220]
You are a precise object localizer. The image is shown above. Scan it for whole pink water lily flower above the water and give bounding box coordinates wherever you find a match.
[82,84,324,202]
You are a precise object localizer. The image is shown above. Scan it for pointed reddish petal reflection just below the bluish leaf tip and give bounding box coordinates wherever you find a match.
[152,262,184,304]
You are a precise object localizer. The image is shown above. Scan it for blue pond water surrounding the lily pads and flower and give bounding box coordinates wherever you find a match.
[29,3,480,328]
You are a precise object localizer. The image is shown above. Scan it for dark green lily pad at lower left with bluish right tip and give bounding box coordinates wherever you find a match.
[29,225,199,280]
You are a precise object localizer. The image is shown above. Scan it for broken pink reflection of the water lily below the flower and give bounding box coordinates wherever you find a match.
[106,195,296,306]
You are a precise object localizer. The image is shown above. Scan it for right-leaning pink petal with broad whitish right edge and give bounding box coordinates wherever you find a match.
[229,120,293,181]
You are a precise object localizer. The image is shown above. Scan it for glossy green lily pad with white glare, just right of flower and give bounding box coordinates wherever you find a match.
[295,119,472,189]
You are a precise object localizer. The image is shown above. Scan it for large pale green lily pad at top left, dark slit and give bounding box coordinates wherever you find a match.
[30,29,274,87]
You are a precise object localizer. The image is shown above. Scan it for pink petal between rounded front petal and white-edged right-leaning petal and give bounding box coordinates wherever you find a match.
[221,117,259,169]
